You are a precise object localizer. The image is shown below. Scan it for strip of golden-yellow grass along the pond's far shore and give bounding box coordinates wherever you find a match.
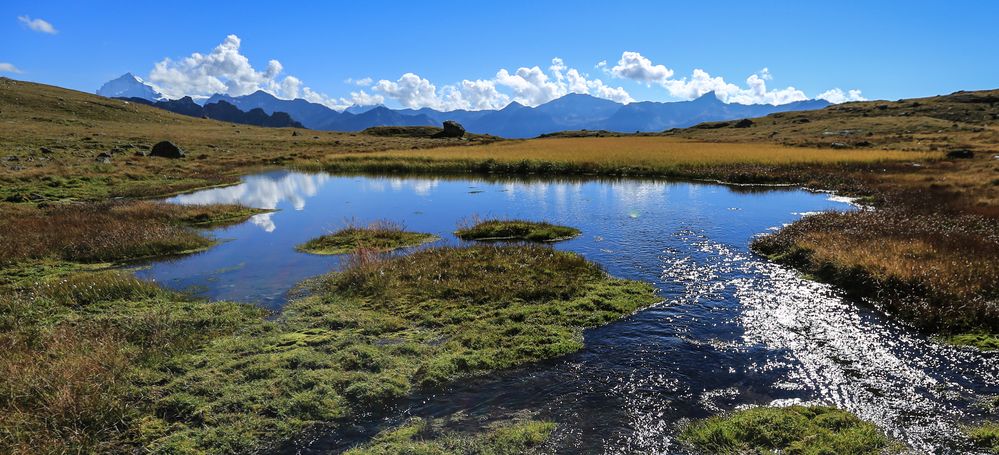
[365,136,941,168]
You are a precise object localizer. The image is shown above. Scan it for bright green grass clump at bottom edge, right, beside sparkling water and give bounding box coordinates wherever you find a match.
[680,406,896,455]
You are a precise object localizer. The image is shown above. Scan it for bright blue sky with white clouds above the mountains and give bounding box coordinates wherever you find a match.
[0,0,999,108]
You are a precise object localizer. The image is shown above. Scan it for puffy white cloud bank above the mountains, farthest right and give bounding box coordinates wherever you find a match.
[598,51,860,105]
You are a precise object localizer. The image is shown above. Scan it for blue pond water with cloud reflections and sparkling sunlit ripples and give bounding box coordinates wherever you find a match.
[138,171,999,453]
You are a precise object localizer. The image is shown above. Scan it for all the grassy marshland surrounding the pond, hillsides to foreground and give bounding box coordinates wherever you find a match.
[0,78,999,453]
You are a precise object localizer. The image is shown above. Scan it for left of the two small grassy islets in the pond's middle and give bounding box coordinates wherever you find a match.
[298,221,439,254]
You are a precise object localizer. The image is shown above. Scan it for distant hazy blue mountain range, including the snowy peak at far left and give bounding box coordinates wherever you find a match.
[97,73,829,138]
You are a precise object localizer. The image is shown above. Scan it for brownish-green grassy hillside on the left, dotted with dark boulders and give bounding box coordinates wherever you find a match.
[0,78,495,202]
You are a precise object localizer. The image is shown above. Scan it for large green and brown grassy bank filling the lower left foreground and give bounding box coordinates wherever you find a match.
[0,246,657,453]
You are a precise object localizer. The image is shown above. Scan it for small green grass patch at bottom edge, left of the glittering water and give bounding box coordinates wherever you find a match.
[346,418,555,455]
